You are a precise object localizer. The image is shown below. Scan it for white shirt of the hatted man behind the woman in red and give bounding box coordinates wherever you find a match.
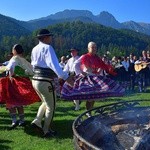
[63,56,79,73]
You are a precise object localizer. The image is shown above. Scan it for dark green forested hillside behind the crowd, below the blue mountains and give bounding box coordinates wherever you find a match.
[0,21,150,62]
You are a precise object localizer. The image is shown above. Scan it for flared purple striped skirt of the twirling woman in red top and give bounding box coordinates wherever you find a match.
[61,74,125,100]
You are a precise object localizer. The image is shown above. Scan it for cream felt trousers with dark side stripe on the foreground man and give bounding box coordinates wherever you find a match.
[32,77,56,133]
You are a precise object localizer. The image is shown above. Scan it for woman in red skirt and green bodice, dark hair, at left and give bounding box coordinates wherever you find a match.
[0,44,39,129]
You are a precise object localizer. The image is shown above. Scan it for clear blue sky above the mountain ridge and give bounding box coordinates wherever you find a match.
[0,0,150,23]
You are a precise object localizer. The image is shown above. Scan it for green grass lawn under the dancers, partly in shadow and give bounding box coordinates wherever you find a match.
[0,90,150,150]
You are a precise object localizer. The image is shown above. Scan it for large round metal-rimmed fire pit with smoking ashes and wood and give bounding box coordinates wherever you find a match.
[73,100,150,150]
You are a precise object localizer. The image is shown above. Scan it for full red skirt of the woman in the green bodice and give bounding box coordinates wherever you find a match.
[0,77,40,107]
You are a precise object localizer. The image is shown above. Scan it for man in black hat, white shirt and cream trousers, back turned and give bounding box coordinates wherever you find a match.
[31,29,68,137]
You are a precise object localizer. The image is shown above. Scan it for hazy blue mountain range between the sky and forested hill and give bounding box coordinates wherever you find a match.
[0,9,150,35]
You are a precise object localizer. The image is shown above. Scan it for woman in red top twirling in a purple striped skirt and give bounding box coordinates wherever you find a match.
[61,42,125,115]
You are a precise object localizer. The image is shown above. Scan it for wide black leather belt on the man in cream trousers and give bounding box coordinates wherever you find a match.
[34,66,56,78]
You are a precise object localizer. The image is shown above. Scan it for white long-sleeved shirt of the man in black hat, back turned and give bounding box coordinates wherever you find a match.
[31,42,68,80]
